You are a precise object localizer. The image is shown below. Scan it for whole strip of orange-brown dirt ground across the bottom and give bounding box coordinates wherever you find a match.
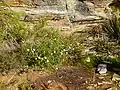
[0,66,120,90]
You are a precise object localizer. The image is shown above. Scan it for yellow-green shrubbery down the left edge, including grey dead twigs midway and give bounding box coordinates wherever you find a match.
[0,1,28,71]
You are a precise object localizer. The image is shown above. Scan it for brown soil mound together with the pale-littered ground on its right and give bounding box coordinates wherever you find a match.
[34,67,114,90]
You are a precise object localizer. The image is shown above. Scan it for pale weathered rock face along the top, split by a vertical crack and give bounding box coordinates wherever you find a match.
[5,0,112,22]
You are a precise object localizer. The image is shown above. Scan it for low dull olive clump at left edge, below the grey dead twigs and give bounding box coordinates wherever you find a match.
[0,51,27,73]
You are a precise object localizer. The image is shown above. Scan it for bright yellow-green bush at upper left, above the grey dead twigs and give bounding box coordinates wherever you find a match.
[0,3,27,43]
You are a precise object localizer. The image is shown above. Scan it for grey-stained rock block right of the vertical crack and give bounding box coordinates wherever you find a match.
[67,0,111,21]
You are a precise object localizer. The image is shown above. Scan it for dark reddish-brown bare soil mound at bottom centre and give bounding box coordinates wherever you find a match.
[35,67,93,90]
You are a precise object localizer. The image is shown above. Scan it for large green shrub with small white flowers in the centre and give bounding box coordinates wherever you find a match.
[22,17,83,69]
